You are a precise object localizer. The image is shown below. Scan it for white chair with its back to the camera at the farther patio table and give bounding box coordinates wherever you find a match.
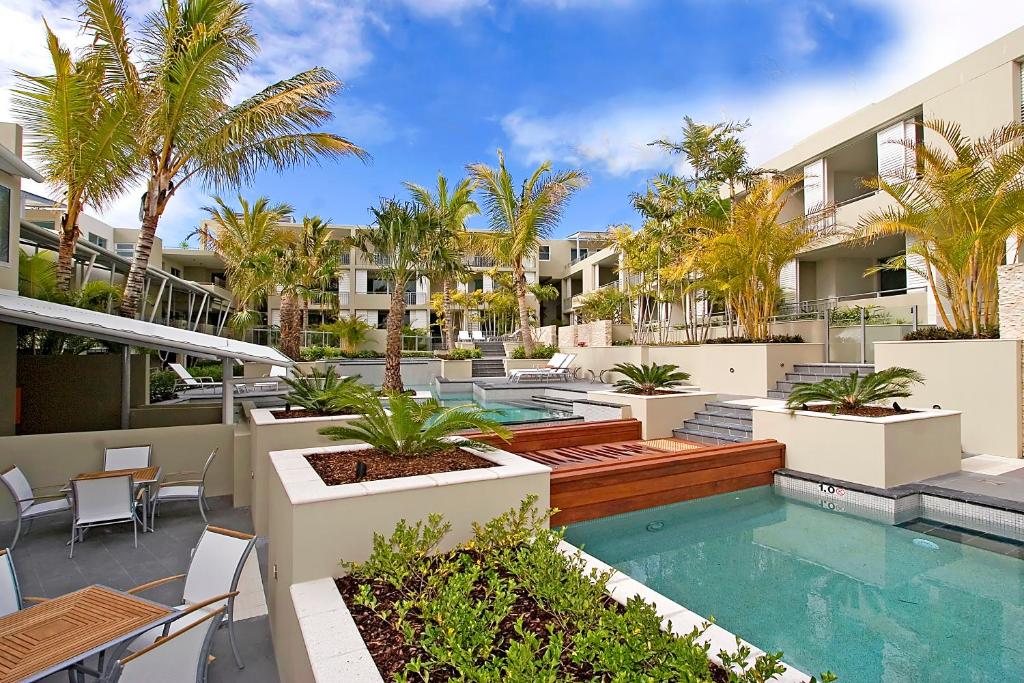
[68,474,142,558]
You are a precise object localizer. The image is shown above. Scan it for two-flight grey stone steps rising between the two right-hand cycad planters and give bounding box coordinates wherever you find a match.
[672,362,874,445]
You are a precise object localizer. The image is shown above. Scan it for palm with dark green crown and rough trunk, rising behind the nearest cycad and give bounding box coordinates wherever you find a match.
[351,200,436,392]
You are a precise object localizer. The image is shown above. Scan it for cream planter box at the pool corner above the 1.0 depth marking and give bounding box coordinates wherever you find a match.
[754,408,962,488]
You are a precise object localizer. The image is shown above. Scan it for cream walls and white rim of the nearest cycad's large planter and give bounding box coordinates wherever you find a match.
[267,444,551,681]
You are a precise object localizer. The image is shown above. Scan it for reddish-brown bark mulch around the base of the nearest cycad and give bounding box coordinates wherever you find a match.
[306,447,497,486]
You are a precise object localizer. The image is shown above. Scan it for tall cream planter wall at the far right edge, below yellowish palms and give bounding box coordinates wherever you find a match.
[874,339,1024,458]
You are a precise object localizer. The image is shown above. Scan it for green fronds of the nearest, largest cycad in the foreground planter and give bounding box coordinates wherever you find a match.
[319,386,511,458]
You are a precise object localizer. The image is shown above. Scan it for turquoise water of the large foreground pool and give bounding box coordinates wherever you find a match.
[566,486,1024,683]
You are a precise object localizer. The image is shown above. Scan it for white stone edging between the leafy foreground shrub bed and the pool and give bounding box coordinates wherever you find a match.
[558,541,811,683]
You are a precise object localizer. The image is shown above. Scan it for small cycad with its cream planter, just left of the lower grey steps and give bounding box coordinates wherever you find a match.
[587,362,717,439]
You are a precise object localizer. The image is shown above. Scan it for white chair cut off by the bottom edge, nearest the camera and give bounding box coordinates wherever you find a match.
[100,596,228,683]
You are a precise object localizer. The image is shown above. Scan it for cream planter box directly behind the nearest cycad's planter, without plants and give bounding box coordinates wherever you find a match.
[244,408,359,536]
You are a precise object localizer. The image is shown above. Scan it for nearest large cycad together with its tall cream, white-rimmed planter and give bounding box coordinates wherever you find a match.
[268,387,551,643]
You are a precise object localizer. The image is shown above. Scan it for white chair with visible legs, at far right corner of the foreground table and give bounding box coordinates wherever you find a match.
[128,526,256,669]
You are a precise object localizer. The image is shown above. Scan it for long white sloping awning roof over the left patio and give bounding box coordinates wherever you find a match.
[0,290,293,367]
